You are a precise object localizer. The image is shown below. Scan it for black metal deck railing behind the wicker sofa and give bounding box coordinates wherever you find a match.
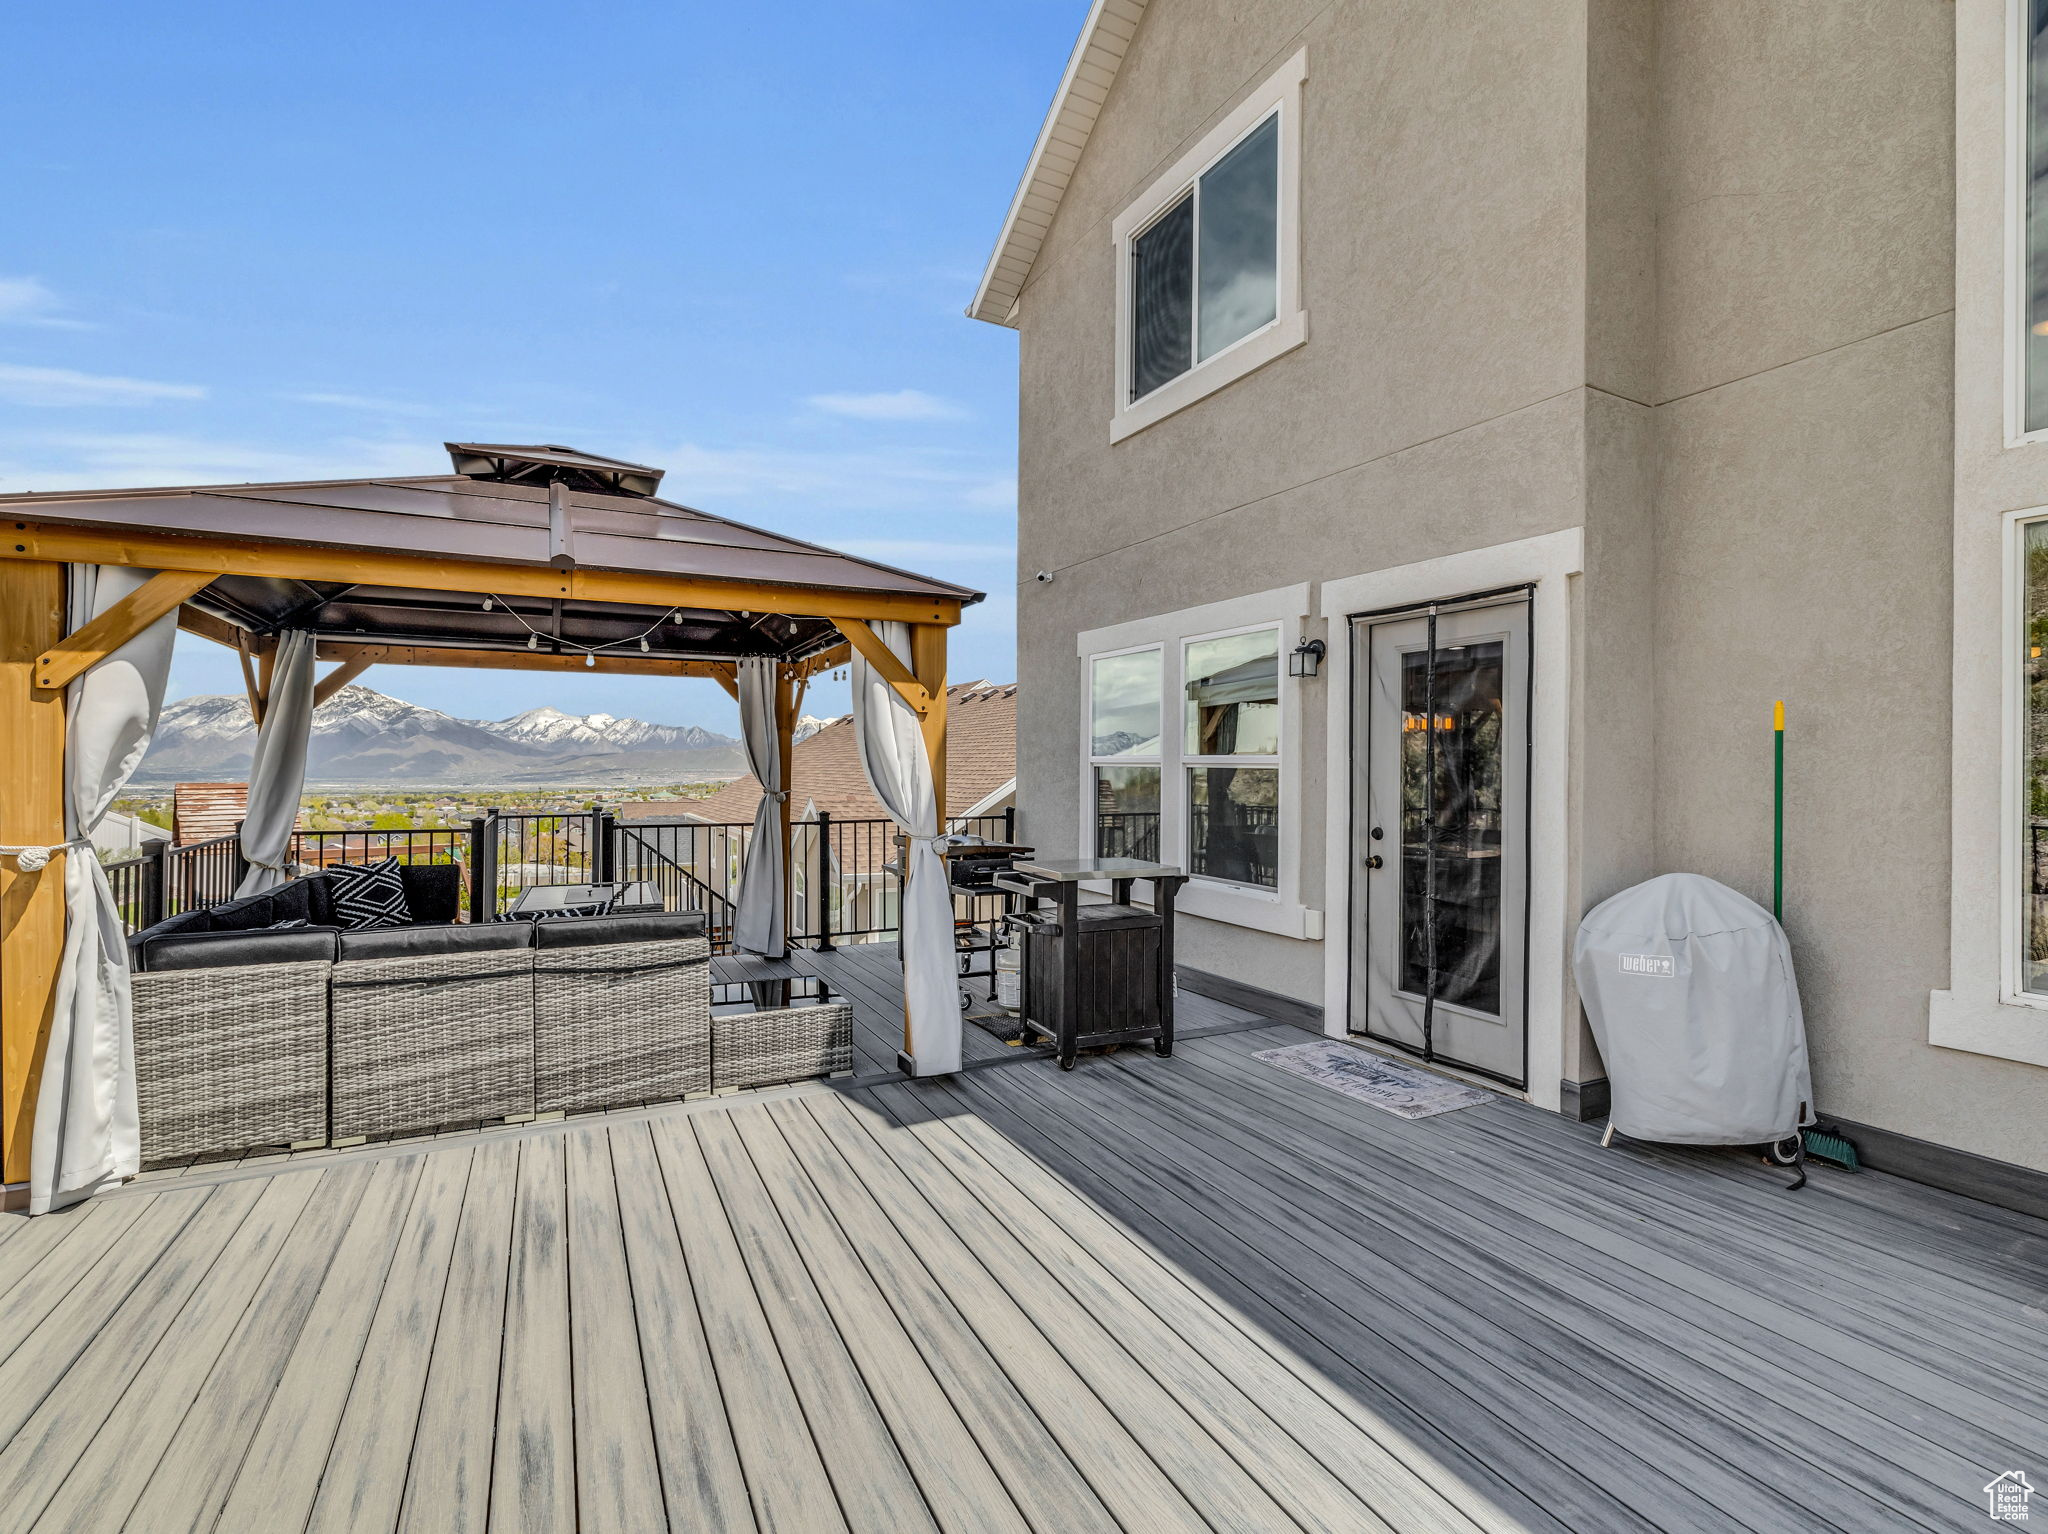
[106,809,1019,952]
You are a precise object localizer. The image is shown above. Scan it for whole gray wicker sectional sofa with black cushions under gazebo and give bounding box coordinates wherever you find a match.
[131,881,852,1165]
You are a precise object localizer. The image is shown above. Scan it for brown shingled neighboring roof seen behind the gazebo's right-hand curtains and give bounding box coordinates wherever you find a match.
[618,682,1018,825]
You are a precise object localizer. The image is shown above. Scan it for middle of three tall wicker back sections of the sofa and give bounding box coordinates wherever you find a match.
[330,928,532,1139]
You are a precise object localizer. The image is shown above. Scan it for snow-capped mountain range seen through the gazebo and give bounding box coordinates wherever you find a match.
[133,686,748,789]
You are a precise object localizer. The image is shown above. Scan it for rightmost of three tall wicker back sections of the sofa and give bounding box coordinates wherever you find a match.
[532,922,711,1112]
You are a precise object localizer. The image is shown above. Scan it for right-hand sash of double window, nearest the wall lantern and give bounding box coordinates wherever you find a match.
[1182,629,1280,889]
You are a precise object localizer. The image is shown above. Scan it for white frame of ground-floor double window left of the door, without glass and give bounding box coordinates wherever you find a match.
[1075,584,1323,940]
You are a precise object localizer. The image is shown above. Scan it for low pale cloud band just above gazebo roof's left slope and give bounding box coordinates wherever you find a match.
[0,432,446,494]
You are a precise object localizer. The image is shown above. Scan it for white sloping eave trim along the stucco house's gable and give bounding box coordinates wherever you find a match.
[967,0,1145,326]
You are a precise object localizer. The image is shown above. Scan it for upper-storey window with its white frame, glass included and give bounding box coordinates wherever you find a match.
[1110,53,1307,440]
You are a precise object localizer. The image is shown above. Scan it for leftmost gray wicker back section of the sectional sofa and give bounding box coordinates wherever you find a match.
[131,961,334,1165]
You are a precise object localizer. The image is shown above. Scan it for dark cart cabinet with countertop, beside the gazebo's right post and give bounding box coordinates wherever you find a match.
[995,858,1186,1071]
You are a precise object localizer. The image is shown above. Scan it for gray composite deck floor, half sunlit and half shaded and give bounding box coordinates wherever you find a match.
[0,1020,2048,1534]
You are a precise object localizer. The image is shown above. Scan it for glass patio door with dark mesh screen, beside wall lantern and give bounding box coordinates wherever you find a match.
[1350,598,1530,1085]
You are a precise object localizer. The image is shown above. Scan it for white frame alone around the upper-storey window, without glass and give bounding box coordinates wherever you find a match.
[1110,49,1309,442]
